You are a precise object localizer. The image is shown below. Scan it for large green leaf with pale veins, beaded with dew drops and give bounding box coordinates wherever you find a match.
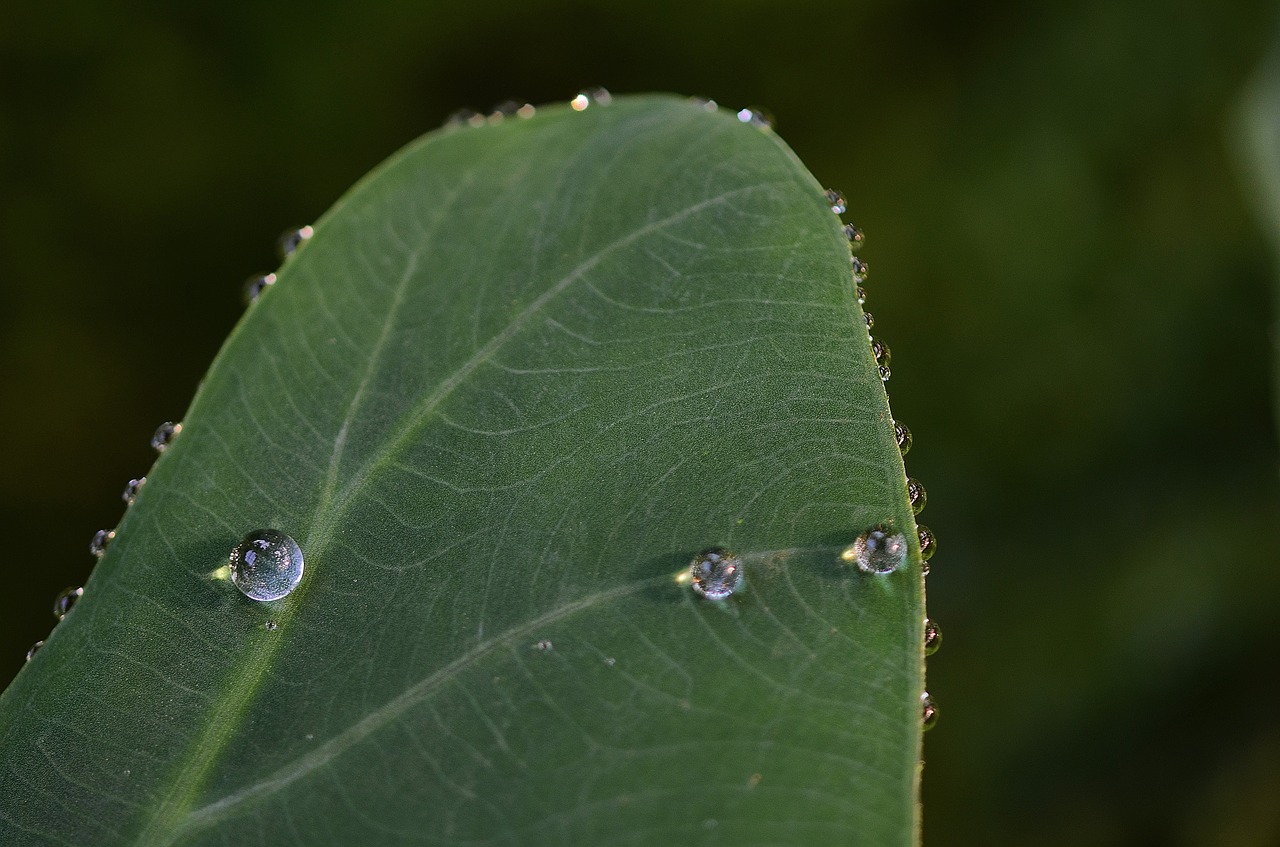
[0,97,923,846]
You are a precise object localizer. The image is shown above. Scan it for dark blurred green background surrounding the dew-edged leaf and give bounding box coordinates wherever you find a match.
[0,0,1280,846]
